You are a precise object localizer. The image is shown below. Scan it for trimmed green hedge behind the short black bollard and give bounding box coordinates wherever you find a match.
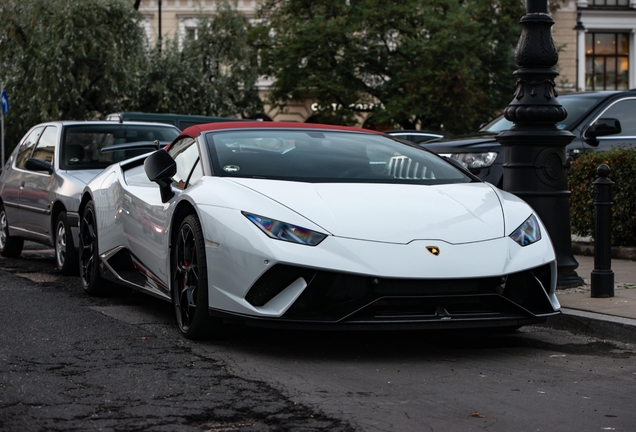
[568,148,636,246]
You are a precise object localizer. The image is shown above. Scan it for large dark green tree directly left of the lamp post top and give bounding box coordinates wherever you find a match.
[256,0,525,133]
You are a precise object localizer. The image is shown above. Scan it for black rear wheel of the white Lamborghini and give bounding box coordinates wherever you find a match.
[79,201,105,296]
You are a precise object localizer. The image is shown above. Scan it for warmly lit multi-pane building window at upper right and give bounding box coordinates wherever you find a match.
[585,32,629,90]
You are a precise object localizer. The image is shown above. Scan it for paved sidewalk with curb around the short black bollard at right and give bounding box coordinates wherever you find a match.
[544,255,636,343]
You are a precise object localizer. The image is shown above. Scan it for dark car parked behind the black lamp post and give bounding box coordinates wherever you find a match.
[425,90,636,187]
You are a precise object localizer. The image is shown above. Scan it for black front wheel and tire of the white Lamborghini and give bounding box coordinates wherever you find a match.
[171,215,222,340]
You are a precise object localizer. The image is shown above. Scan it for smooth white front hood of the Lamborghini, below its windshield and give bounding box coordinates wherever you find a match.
[226,179,504,244]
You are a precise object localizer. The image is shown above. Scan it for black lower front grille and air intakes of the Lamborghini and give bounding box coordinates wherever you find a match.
[246,264,554,322]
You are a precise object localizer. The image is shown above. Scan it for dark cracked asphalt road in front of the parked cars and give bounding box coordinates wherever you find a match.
[0,250,636,431]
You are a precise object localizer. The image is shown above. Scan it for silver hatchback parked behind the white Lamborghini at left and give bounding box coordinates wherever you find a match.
[0,121,180,274]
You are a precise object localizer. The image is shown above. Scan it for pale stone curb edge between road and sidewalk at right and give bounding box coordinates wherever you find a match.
[540,308,636,344]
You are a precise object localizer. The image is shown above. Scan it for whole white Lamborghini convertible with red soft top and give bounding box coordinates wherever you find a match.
[80,122,560,338]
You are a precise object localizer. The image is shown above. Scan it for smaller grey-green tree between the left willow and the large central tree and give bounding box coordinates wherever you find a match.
[137,2,263,117]
